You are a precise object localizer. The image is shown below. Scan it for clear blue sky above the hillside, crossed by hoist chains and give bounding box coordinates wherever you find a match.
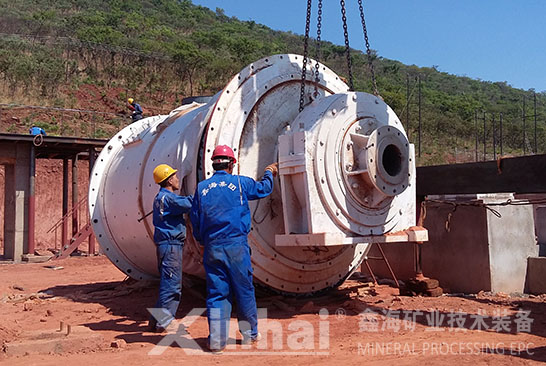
[192,0,546,92]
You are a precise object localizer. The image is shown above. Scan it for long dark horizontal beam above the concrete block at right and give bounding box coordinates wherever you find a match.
[416,155,546,196]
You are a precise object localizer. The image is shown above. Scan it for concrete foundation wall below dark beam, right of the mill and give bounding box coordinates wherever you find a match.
[370,199,538,293]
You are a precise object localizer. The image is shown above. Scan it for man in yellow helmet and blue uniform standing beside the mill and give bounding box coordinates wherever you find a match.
[150,164,193,332]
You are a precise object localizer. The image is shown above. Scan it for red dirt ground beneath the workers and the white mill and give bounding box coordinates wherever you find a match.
[0,256,546,366]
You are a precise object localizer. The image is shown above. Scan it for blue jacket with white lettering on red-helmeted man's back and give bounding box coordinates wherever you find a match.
[190,170,273,245]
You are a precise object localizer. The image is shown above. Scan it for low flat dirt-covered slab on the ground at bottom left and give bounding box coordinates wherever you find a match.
[4,326,104,357]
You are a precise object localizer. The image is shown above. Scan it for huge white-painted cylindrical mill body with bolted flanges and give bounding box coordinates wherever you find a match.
[89,54,415,293]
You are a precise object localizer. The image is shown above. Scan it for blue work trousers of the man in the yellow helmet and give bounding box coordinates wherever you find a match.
[152,244,183,328]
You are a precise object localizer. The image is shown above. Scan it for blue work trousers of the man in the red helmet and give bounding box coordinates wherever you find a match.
[204,237,258,349]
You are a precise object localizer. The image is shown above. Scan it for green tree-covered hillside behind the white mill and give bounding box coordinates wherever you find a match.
[0,0,546,164]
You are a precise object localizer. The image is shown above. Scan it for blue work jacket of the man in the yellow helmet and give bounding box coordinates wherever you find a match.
[153,188,193,245]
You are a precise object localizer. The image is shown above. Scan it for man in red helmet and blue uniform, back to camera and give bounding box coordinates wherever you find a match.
[190,145,277,353]
